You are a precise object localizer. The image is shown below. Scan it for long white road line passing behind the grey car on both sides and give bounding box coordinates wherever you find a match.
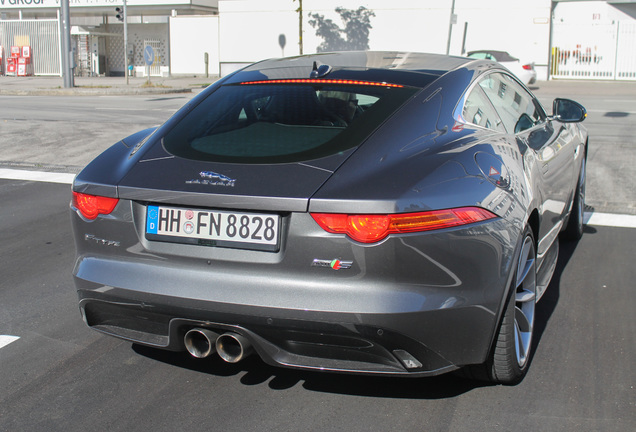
[0,168,636,228]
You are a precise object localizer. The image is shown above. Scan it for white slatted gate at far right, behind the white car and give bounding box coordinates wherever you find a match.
[550,21,636,81]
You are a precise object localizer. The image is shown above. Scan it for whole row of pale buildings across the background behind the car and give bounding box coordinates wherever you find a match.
[0,0,636,80]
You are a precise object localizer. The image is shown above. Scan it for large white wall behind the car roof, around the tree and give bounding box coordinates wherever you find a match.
[219,0,551,79]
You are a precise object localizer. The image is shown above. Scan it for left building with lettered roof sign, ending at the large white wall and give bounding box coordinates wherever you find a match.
[0,0,218,76]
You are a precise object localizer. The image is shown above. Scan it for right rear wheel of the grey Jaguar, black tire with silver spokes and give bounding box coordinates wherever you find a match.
[460,228,536,385]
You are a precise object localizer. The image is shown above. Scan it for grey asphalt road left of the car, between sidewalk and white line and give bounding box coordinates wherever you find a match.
[0,94,193,171]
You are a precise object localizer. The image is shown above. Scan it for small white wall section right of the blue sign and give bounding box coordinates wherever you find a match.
[170,15,220,76]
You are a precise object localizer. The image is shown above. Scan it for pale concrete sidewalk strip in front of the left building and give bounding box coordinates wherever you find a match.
[0,76,218,96]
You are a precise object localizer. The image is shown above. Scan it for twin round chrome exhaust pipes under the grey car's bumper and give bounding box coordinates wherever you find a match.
[183,328,254,363]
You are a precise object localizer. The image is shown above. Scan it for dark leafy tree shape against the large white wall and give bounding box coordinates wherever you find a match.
[309,6,375,52]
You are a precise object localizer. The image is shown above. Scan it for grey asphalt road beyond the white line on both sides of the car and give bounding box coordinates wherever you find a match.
[0,81,636,215]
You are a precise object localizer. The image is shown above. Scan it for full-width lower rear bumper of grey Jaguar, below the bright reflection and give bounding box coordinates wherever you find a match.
[76,258,516,376]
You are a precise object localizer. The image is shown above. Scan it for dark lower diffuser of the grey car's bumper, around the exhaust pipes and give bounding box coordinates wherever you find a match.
[80,292,456,376]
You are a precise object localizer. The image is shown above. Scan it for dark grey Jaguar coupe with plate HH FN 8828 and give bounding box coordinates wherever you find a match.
[71,52,588,384]
